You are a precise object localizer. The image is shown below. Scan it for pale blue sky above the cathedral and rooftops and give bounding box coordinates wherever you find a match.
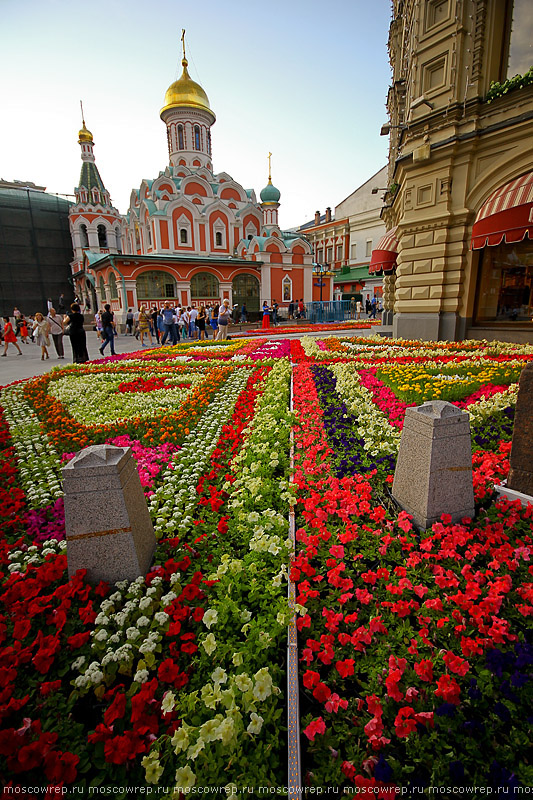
[0,0,391,228]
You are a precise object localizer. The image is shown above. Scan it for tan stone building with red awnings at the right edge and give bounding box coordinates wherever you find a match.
[378,0,533,342]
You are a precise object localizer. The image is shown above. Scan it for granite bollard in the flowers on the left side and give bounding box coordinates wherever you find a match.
[63,444,156,584]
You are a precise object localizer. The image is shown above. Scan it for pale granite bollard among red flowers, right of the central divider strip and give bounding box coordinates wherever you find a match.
[392,400,474,530]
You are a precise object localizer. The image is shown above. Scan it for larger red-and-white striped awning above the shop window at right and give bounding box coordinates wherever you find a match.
[471,172,533,250]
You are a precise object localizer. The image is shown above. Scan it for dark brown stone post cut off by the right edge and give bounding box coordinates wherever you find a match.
[507,363,533,496]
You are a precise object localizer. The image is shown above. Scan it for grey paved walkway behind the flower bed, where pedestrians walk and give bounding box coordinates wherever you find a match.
[0,326,391,386]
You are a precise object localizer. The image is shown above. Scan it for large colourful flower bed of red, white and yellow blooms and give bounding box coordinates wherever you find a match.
[0,337,533,798]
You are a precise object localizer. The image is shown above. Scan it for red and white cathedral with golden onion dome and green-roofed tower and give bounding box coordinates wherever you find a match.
[70,42,316,321]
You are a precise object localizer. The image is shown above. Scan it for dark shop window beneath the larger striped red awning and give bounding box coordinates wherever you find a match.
[475,239,533,325]
